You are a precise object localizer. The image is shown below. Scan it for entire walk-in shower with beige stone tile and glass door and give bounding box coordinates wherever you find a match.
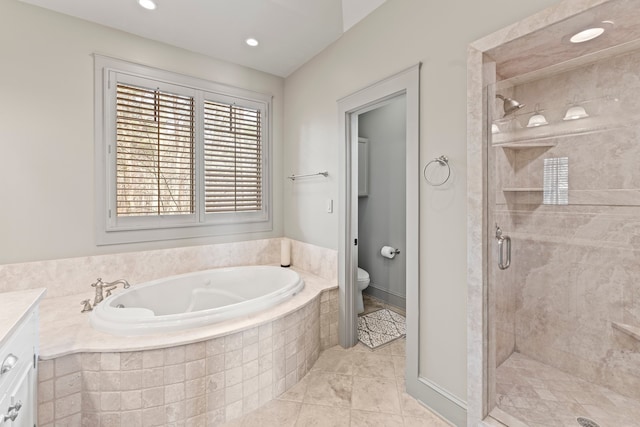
[468,0,640,427]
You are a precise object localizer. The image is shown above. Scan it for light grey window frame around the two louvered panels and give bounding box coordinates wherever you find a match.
[94,55,273,245]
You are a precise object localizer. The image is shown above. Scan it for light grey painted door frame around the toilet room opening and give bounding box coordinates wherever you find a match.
[338,64,421,386]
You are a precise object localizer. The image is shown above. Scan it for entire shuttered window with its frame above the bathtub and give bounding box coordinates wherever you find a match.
[95,56,272,244]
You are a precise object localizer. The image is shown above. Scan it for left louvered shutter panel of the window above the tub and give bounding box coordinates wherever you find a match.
[116,84,195,216]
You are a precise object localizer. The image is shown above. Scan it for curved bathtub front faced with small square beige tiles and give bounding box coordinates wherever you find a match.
[38,289,337,427]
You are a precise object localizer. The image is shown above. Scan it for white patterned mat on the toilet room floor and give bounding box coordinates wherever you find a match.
[358,308,407,350]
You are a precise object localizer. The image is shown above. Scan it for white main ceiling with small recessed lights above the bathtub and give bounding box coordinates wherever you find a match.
[21,0,385,77]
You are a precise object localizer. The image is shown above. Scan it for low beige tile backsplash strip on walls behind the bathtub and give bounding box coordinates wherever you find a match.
[0,238,338,298]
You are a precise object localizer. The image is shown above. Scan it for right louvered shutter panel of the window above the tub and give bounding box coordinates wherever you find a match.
[204,101,262,213]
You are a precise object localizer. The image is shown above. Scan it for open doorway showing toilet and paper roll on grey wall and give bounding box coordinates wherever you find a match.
[354,98,407,318]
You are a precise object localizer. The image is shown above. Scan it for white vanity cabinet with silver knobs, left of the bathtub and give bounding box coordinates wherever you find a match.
[0,292,44,427]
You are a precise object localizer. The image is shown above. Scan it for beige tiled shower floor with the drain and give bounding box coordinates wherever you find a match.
[496,353,640,427]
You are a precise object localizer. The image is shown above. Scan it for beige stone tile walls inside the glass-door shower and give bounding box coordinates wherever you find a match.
[491,48,640,399]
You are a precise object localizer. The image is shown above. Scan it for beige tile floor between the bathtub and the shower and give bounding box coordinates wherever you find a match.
[225,300,449,427]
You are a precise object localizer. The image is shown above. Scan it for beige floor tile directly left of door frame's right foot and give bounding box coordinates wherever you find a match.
[351,377,401,415]
